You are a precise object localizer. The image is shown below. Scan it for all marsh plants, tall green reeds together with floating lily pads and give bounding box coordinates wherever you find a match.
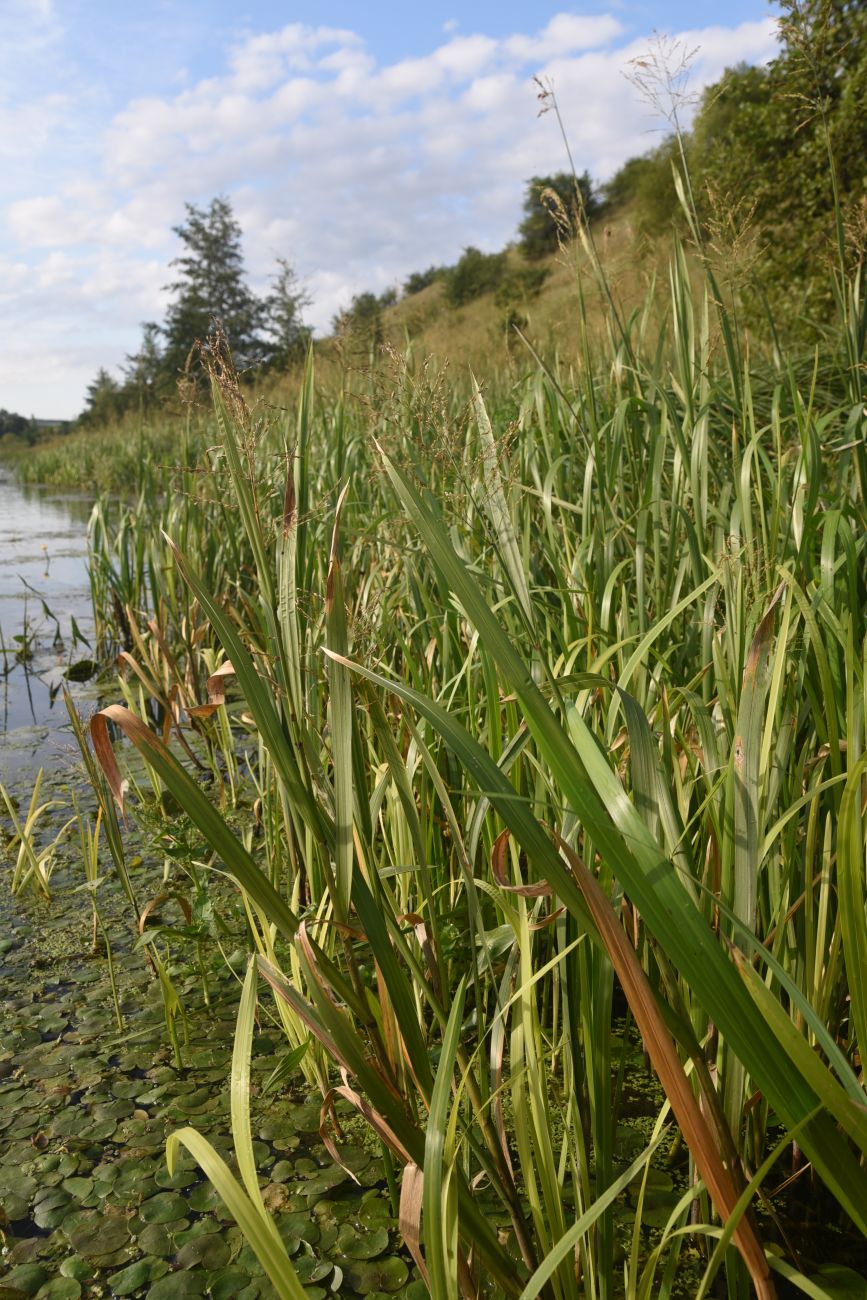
[0,5,867,1300]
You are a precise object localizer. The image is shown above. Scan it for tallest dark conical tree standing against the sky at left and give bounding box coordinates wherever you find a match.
[162,198,266,374]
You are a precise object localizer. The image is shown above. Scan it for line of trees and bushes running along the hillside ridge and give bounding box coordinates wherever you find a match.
[64,0,867,424]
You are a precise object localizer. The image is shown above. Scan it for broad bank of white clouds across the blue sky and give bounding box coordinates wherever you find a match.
[0,4,775,413]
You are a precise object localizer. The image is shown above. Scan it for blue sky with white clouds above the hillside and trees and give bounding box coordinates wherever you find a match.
[0,0,776,419]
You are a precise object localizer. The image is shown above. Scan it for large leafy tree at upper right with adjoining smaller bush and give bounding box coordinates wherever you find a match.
[603,0,867,319]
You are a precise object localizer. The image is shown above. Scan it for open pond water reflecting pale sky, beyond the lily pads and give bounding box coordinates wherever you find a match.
[0,465,96,783]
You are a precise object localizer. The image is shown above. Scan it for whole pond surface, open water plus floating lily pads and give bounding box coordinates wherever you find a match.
[0,467,426,1300]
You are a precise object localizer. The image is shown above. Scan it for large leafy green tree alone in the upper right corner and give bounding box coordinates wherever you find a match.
[689,0,867,317]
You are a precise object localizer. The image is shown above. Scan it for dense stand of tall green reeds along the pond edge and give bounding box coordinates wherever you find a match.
[62,213,867,1300]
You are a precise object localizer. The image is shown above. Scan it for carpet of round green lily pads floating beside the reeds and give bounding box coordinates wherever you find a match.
[0,785,426,1300]
